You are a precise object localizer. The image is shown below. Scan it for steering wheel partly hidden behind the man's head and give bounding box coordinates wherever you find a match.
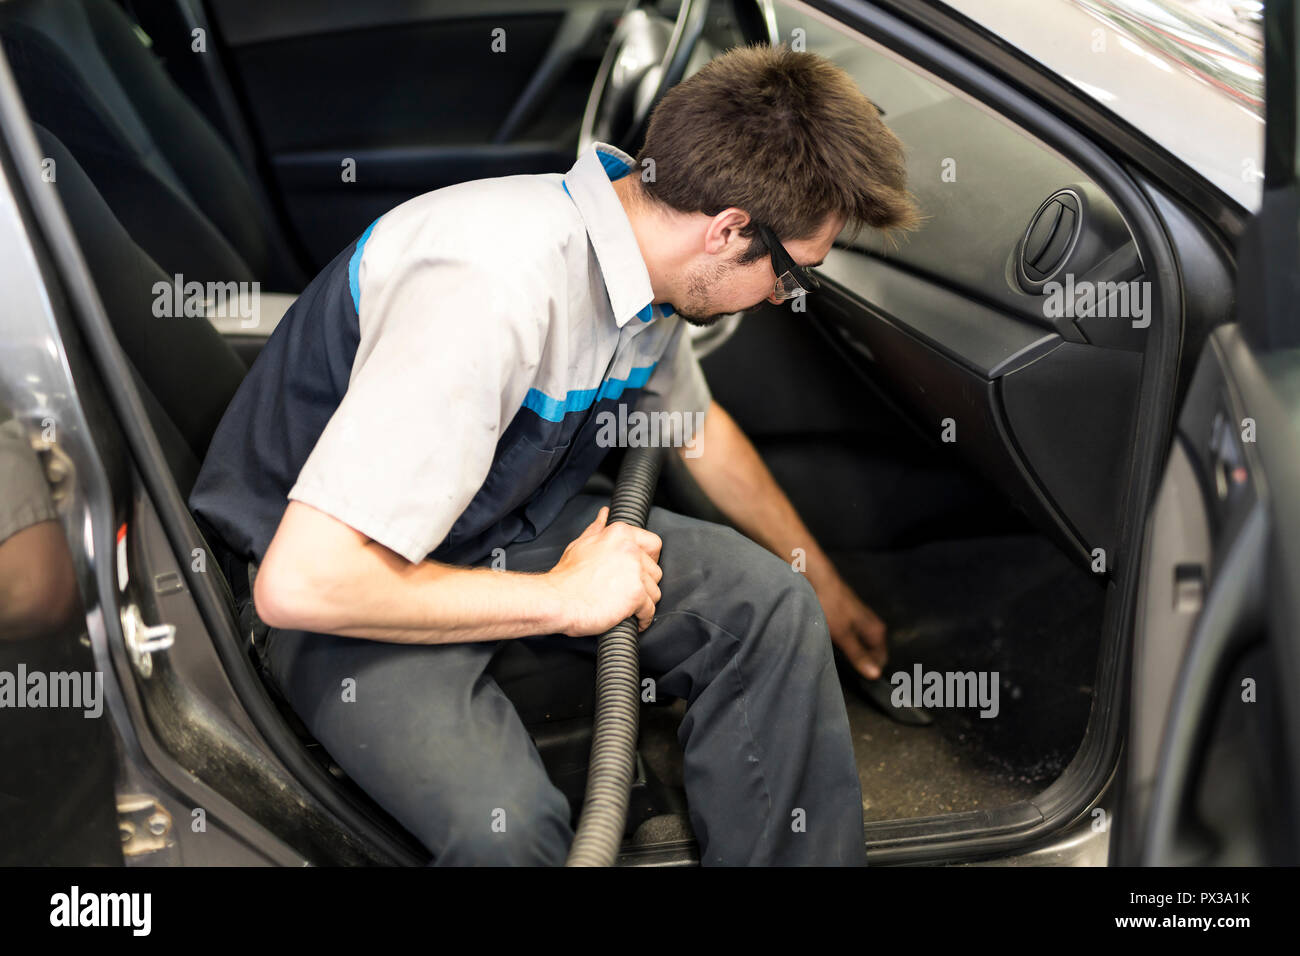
[577,0,709,155]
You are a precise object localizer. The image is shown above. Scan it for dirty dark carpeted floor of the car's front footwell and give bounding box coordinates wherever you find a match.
[637,535,1102,842]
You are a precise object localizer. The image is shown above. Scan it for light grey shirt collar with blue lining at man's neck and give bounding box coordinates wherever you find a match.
[563,143,660,329]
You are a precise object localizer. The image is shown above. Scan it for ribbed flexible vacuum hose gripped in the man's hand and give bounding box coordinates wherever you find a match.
[566,447,663,866]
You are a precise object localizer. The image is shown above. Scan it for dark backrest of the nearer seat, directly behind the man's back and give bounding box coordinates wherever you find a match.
[35,124,247,496]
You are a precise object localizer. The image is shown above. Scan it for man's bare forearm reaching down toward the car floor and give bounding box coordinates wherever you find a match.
[681,402,836,587]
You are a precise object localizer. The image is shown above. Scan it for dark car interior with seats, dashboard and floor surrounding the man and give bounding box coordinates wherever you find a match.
[0,0,1230,857]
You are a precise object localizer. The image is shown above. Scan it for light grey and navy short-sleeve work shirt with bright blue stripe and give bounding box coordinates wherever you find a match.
[191,143,710,563]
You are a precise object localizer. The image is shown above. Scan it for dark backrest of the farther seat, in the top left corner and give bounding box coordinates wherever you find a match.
[0,0,303,291]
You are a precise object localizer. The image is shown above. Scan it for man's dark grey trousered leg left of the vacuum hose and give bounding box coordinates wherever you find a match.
[268,631,572,864]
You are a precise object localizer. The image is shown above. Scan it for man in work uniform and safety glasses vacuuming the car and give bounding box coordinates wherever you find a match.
[191,47,914,865]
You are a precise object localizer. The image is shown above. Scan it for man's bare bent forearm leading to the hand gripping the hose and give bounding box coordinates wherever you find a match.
[254,502,566,644]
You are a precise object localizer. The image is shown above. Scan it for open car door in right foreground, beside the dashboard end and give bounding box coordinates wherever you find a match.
[1112,4,1300,865]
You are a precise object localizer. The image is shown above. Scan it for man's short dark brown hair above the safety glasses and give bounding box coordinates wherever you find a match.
[637,46,919,263]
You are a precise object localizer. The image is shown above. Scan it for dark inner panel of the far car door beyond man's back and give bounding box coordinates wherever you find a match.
[191,0,625,271]
